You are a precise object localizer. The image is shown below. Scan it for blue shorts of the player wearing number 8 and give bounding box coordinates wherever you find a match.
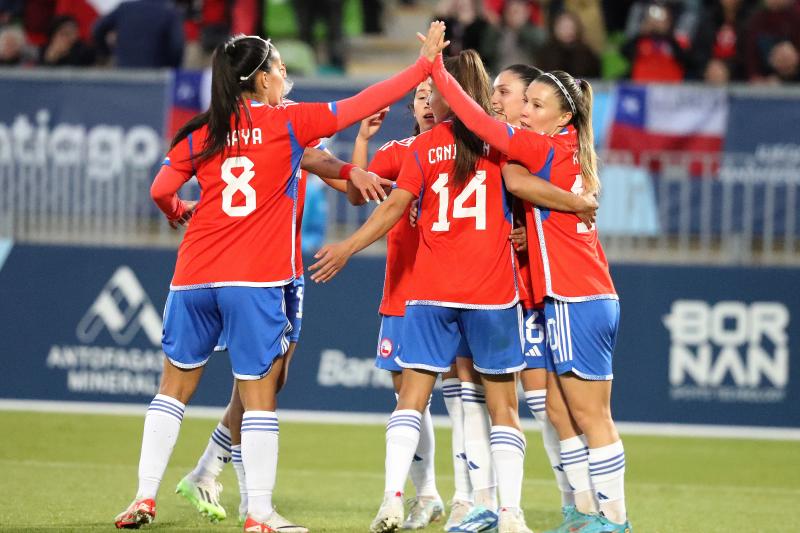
[161,287,291,380]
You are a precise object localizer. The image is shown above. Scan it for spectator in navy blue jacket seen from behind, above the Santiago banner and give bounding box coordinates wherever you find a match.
[94,0,184,68]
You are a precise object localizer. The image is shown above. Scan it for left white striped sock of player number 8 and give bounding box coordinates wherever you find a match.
[136,394,186,500]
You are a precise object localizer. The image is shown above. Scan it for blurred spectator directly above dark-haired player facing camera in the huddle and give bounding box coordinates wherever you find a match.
[487,0,545,72]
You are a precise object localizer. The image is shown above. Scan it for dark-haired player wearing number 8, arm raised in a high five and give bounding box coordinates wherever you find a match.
[116,22,444,532]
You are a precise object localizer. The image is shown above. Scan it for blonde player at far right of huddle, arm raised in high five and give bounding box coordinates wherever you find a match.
[434,55,630,533]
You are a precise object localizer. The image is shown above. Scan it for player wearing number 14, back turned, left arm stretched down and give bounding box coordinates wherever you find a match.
[311,51,529,532]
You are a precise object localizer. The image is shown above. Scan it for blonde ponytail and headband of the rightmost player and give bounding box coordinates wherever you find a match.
[536,70,600,193]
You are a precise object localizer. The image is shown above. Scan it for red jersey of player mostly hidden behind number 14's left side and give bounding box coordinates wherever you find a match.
[368,137,419,316]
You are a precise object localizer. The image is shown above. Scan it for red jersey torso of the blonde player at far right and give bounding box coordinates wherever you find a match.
[508,127,617,302]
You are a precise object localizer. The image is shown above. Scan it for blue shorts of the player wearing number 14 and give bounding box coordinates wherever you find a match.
[396,305,525,374]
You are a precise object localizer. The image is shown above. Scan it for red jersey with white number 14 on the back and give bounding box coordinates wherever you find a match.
[397,122,519,309]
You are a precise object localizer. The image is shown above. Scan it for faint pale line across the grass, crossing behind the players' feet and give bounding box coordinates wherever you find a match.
[0,459,800,496]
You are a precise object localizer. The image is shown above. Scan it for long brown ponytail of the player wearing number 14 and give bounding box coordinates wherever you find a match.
[444,50,492,185]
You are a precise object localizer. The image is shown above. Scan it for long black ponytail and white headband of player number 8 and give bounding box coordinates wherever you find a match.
[171,35,273,161]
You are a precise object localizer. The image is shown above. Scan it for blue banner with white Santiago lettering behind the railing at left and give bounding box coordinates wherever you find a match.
[0,71,170,224]
